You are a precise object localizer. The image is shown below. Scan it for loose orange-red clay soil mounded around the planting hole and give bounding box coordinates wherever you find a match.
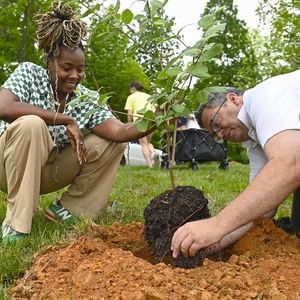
[11,218,300,300]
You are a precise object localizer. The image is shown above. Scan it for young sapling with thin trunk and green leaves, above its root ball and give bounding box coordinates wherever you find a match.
[77,0,225,193]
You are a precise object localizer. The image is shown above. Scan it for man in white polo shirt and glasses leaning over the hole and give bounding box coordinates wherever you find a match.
[171,71,300,257]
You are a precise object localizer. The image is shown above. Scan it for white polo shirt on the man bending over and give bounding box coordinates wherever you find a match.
[238,70,300,181]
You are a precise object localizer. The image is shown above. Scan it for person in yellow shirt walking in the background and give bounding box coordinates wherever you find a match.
[124,81,160,167]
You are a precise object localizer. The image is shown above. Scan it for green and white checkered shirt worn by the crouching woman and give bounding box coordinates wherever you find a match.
[0,62,115,148]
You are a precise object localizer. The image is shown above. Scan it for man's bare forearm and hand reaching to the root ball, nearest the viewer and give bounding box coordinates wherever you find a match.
[171,130,300,257]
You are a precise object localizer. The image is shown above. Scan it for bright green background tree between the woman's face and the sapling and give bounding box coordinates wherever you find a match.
[85,3,150,122]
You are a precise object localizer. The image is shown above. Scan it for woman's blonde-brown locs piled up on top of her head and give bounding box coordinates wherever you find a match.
[34,1,87,62]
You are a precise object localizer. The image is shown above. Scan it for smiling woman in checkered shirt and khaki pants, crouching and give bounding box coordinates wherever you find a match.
[0,1,155,243]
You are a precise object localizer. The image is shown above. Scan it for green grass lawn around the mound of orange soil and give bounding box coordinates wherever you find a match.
[0,162,291,299]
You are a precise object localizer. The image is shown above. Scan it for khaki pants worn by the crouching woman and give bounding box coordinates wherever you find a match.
[0,115,126,233]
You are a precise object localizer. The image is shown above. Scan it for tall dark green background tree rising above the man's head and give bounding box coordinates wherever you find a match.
[192,0,260,99]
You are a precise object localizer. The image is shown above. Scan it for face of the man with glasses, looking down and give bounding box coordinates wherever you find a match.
[202,93,249,142]
